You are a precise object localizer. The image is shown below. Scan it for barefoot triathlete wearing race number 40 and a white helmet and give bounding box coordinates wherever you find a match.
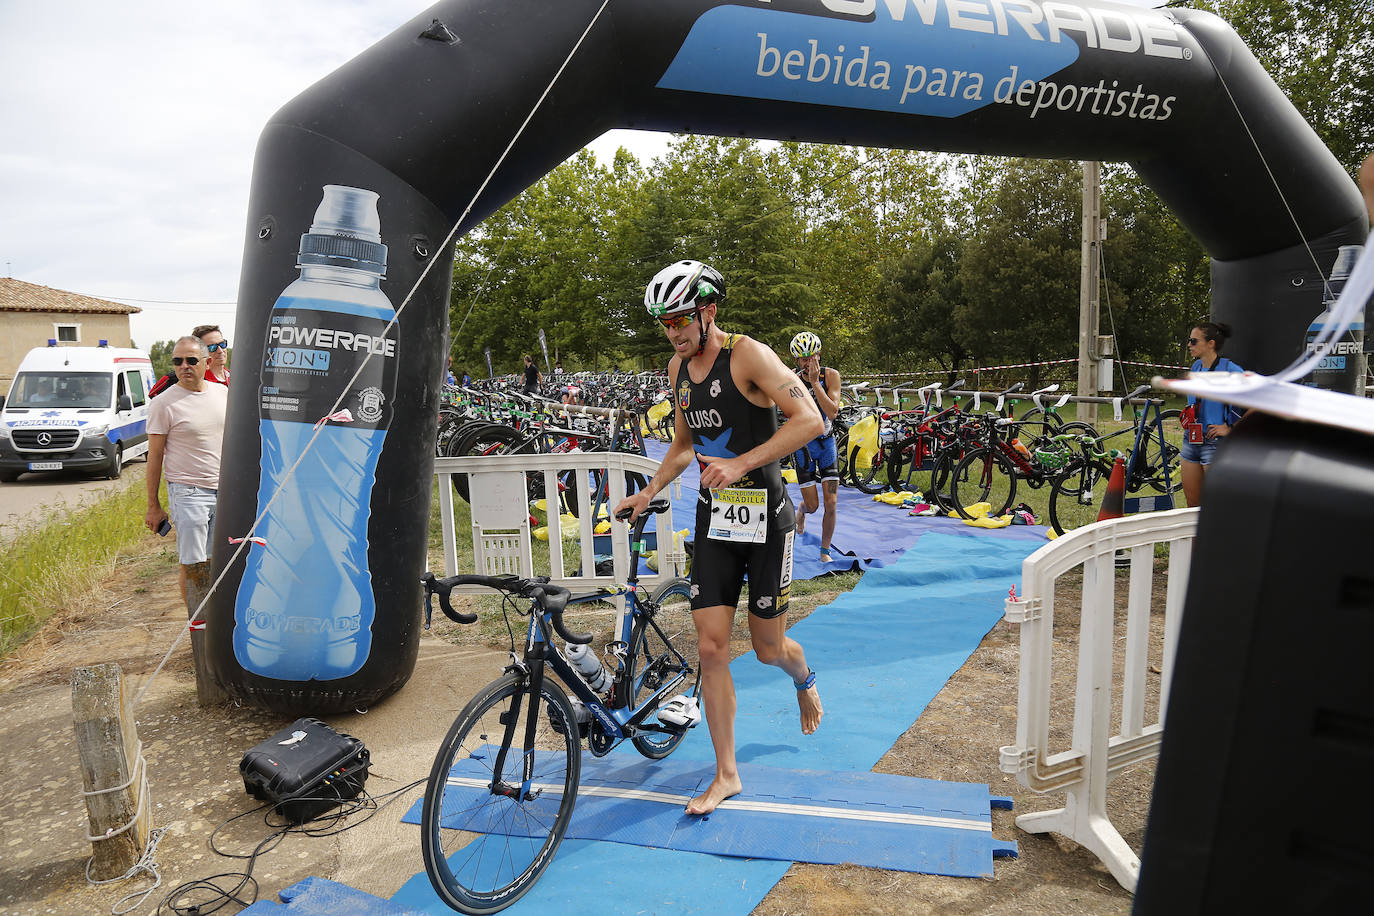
[616,261,822,814]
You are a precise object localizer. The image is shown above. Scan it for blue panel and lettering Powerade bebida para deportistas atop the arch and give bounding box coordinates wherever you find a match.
[658,0,1193,121]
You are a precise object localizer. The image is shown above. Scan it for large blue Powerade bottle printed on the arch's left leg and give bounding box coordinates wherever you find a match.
[234,185,397,681]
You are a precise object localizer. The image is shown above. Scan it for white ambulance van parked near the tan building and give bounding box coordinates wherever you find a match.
[0,341,154,483]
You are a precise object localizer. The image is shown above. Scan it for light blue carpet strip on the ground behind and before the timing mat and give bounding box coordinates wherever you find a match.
[256,488,1044,916]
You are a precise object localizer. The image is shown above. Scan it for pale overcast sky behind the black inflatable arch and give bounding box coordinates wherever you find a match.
[0,0,1154,347]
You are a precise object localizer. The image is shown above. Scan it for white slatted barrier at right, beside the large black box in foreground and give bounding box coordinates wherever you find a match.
[1000,508,1198,893]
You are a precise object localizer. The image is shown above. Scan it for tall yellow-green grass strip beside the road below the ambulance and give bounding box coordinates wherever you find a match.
[0,482,155,656]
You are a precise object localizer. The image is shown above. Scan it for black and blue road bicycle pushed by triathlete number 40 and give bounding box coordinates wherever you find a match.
[420,497,701,913]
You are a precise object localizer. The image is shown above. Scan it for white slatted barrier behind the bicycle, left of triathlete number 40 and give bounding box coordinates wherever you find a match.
[434,452,687,593]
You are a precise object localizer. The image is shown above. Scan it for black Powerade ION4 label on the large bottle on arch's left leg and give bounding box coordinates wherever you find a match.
[258,299,397,430]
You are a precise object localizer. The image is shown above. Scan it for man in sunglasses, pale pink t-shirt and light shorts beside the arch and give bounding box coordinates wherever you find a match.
[143,336,229,611]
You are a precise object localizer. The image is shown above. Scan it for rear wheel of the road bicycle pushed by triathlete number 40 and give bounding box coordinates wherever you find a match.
[625,578,701,759]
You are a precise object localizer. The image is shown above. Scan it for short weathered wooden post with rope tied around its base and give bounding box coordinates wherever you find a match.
[71,665,151,880]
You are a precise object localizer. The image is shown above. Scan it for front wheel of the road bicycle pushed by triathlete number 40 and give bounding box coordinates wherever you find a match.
[420,674,581,913]
